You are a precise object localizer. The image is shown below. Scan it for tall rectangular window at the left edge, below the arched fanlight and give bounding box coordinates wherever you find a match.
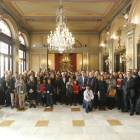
[0,41,13,77]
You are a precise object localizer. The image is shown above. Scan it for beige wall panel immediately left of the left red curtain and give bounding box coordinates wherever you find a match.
[48,54,55,70]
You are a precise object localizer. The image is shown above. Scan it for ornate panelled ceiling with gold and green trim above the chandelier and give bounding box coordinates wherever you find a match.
[2,0,127,32]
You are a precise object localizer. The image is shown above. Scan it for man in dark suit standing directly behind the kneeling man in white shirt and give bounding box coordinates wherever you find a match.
[87,72,98,109]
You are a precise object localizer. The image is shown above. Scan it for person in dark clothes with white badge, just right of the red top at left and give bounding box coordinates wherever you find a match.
[45,79,54,108]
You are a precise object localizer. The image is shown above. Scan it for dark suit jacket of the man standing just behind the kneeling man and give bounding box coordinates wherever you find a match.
[87,77,98,93]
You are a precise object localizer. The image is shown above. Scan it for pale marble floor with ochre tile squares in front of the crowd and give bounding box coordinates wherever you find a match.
[0,104,140,140]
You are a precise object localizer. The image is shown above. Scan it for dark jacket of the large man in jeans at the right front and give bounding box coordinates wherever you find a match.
[122,77,136,95]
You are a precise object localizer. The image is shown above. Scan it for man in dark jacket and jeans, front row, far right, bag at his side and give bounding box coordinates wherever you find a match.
[122,71,135,116]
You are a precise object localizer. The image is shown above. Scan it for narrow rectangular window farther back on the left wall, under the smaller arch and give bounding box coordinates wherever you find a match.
[19,50,26,73]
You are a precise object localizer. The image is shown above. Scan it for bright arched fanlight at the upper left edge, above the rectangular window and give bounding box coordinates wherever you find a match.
[0,20,11,37]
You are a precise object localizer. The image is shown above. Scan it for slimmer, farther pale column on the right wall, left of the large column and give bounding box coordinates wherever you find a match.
[108,38,114,71]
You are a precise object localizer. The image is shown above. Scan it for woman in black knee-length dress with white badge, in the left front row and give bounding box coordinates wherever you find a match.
[27,76,37,108]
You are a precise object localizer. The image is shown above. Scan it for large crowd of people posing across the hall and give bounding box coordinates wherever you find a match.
[0,68,140,116]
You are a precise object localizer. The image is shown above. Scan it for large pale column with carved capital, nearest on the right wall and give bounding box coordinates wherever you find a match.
[124,23,137,71]
